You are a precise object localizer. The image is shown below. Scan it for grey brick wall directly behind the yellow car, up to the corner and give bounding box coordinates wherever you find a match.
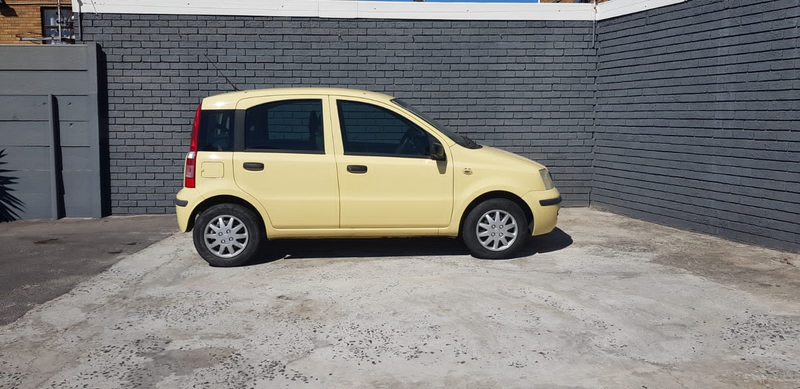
[82,13,596,214]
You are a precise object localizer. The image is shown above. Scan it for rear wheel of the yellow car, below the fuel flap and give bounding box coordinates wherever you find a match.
[192,204,266,267]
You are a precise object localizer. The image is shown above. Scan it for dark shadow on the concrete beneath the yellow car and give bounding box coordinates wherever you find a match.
[245,228,572,266]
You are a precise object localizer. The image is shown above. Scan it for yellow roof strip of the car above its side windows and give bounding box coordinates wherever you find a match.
[203,88,394,109]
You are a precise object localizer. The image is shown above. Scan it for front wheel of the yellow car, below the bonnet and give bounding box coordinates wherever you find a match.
[461,199,530,259]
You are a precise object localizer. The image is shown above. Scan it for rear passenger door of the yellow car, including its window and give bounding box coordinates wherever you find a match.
[233,95,339,229]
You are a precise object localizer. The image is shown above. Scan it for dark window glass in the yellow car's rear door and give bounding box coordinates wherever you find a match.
[244,99,325,154]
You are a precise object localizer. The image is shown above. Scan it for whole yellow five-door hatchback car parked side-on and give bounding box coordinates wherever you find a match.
[175,88,561,266]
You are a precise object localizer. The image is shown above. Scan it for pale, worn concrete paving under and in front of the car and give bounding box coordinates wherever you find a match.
[0,209,800,389]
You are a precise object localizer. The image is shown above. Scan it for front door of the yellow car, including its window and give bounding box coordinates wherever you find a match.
[331,98,453,228]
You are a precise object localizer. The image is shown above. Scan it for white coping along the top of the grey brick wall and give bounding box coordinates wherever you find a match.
[76,0,686,21]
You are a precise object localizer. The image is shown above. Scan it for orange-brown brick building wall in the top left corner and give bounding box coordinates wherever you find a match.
[0,0,71,44]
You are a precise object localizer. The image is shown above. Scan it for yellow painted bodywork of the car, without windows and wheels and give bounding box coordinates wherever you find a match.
[176,88,560,239]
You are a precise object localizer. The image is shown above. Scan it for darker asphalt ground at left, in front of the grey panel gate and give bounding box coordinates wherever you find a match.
[0,215,178,325]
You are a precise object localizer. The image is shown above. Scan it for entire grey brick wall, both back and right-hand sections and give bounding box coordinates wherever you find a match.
[76,0,800,251]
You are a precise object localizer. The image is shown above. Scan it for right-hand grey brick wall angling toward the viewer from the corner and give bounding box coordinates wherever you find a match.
[591,0,800,251]
